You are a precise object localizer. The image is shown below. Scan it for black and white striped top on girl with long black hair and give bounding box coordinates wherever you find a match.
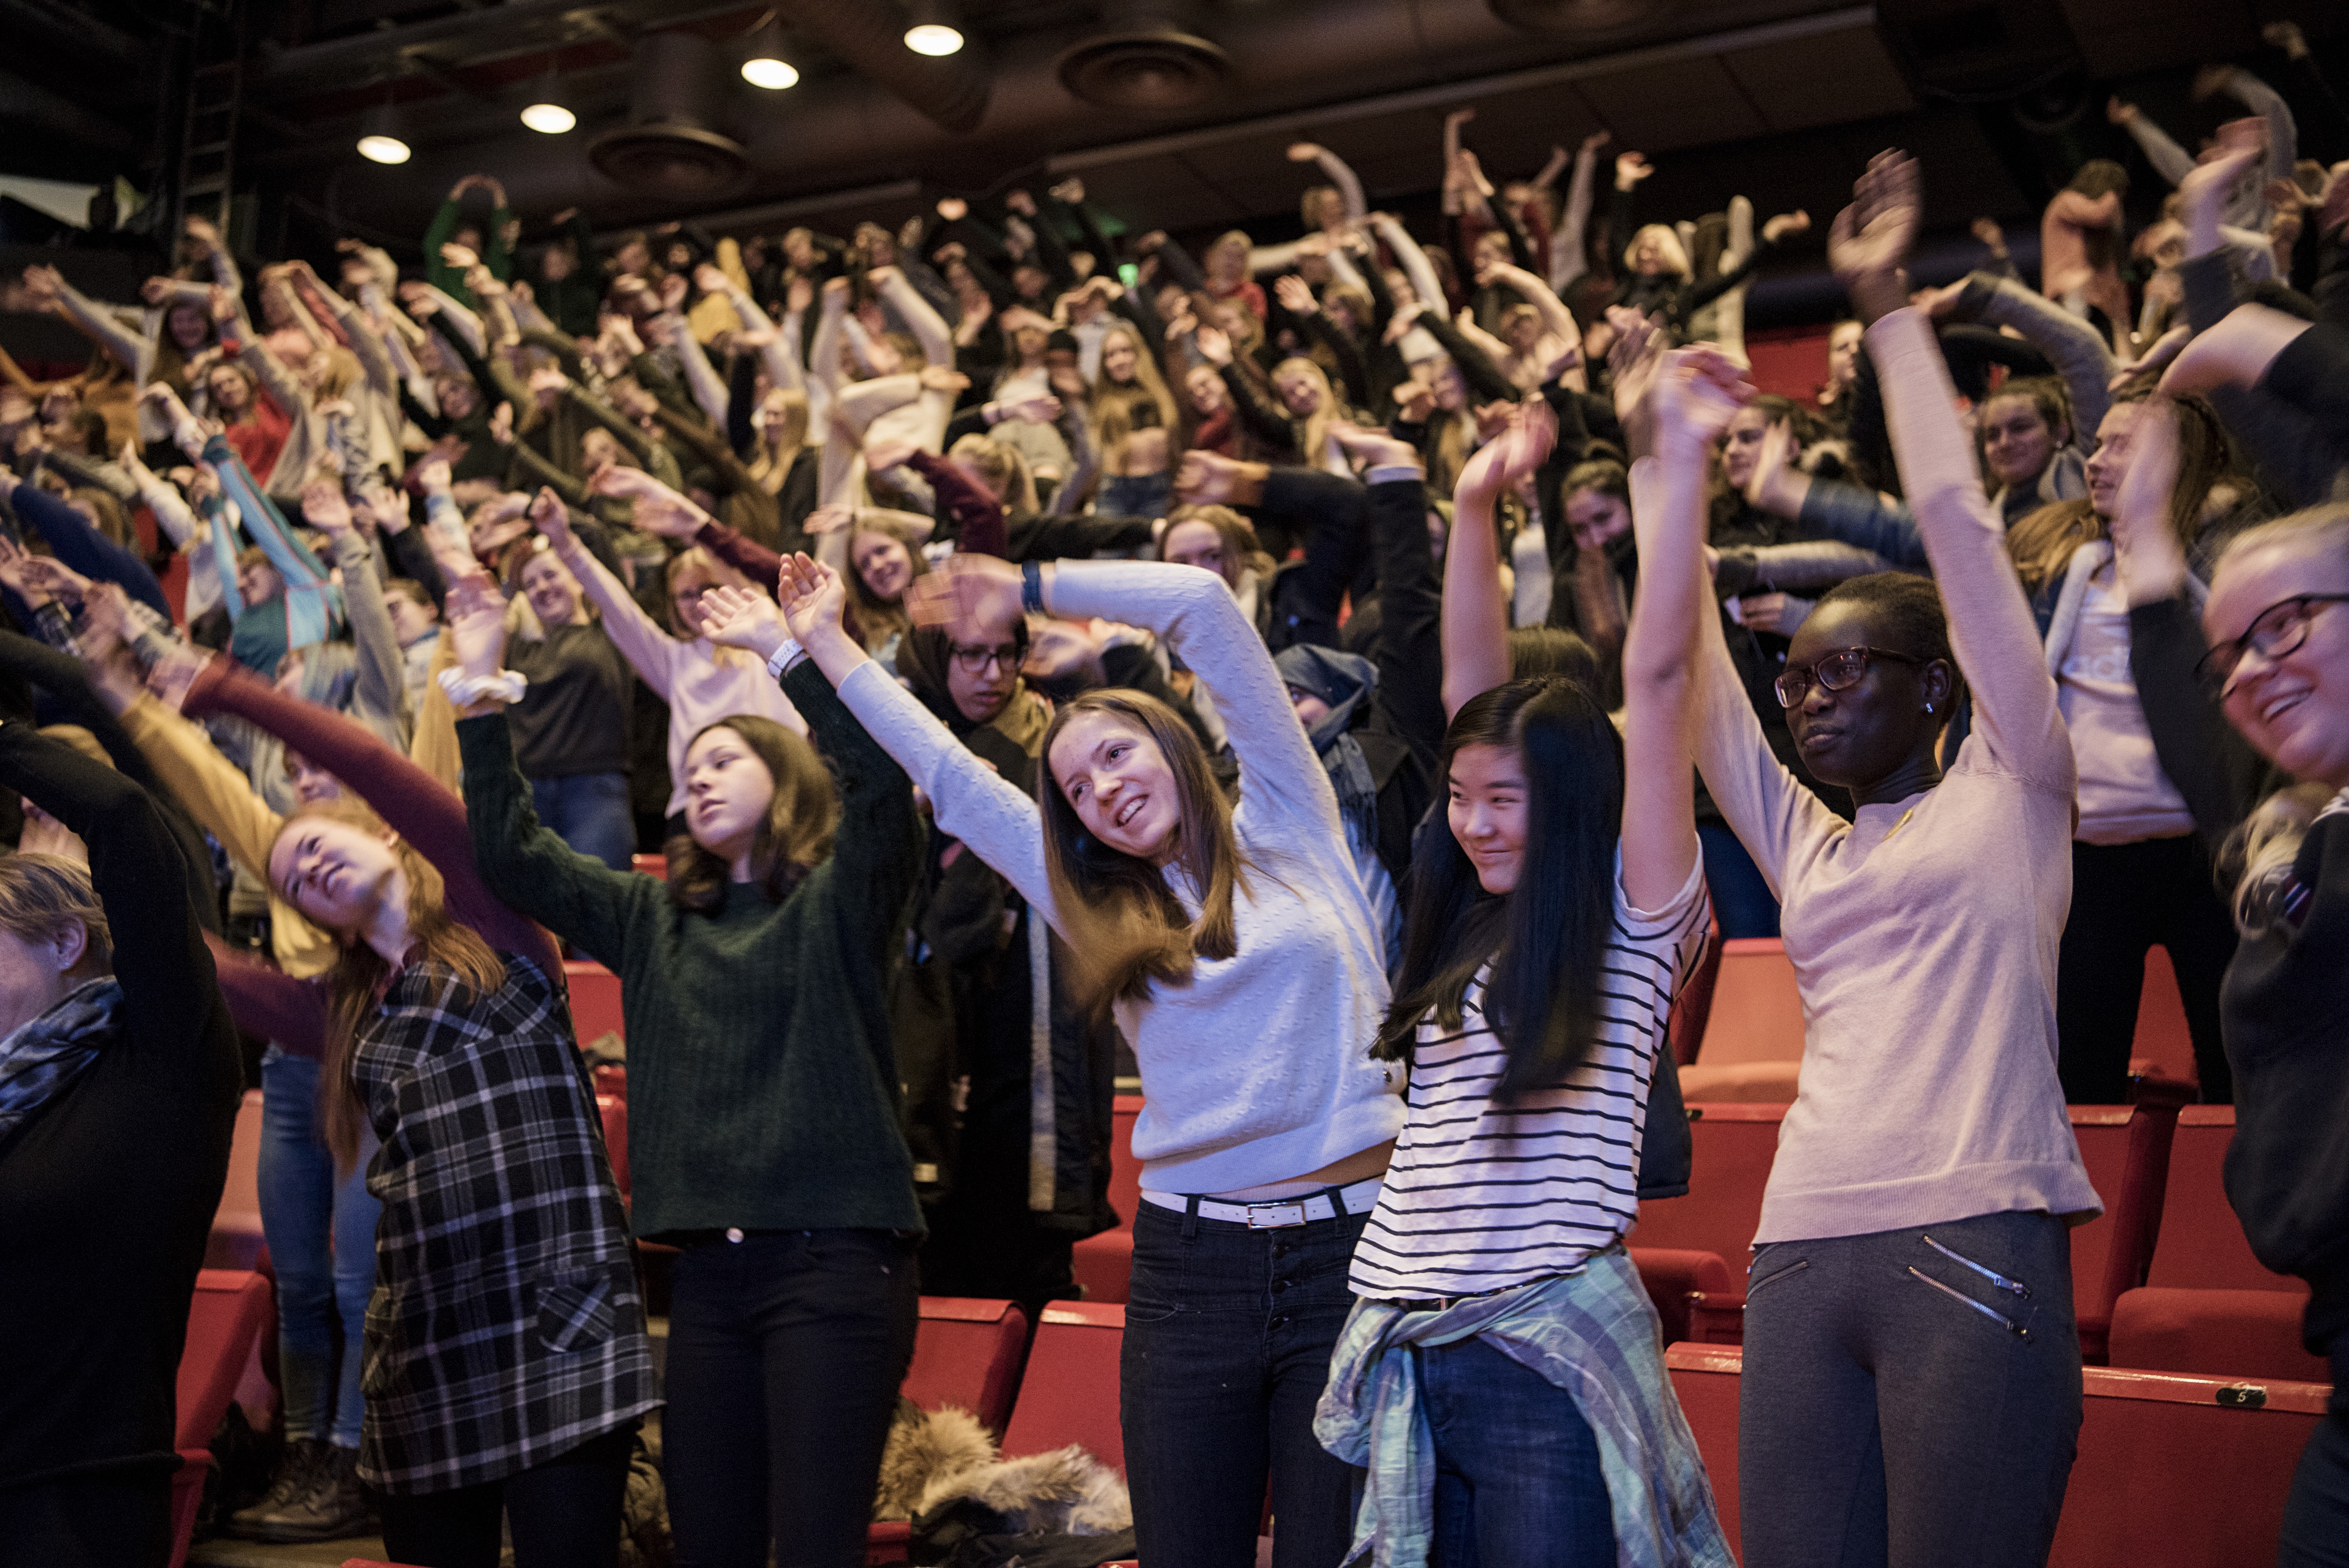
[1351,866,1710,1301]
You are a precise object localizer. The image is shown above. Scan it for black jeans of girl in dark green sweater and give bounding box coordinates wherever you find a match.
[660,1230,921,1568]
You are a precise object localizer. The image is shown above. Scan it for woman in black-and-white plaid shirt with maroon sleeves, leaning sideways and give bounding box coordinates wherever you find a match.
[125,629,658,1568]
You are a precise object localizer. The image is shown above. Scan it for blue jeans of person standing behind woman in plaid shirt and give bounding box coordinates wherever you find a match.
[258,1044,383,1448]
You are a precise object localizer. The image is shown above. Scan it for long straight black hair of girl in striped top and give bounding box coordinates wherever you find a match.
[1372,676,1623,1099]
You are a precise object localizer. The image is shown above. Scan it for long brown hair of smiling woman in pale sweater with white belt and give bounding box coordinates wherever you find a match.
[1036,690,1247,1012]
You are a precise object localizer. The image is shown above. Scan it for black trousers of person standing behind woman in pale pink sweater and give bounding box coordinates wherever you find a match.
[2055,833,2234,1106]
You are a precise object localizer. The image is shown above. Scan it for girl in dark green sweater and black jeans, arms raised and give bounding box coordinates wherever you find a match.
[449,551,925,1568]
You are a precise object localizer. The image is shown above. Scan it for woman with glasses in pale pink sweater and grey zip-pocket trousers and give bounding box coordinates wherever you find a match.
[1665,153,2100,1568]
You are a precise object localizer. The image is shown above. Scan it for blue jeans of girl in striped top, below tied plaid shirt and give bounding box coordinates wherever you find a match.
[1412,1338,1616,1568]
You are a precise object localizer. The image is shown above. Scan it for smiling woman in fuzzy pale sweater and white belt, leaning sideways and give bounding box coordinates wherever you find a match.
[747,540,1403,1568]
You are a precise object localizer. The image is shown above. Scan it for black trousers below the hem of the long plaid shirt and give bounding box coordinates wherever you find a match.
[376,1420,636,1568]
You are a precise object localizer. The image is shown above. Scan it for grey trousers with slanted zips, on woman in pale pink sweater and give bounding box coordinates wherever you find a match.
[1738,1211,2081,1568]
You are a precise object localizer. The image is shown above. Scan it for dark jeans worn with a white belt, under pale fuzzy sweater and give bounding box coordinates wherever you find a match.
[1121,1202,1369,1568]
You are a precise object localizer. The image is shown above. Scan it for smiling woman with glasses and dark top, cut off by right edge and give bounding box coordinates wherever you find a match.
[2114,305,2349,1566]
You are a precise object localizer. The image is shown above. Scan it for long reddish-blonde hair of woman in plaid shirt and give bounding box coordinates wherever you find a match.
[270,798,505,1171]
